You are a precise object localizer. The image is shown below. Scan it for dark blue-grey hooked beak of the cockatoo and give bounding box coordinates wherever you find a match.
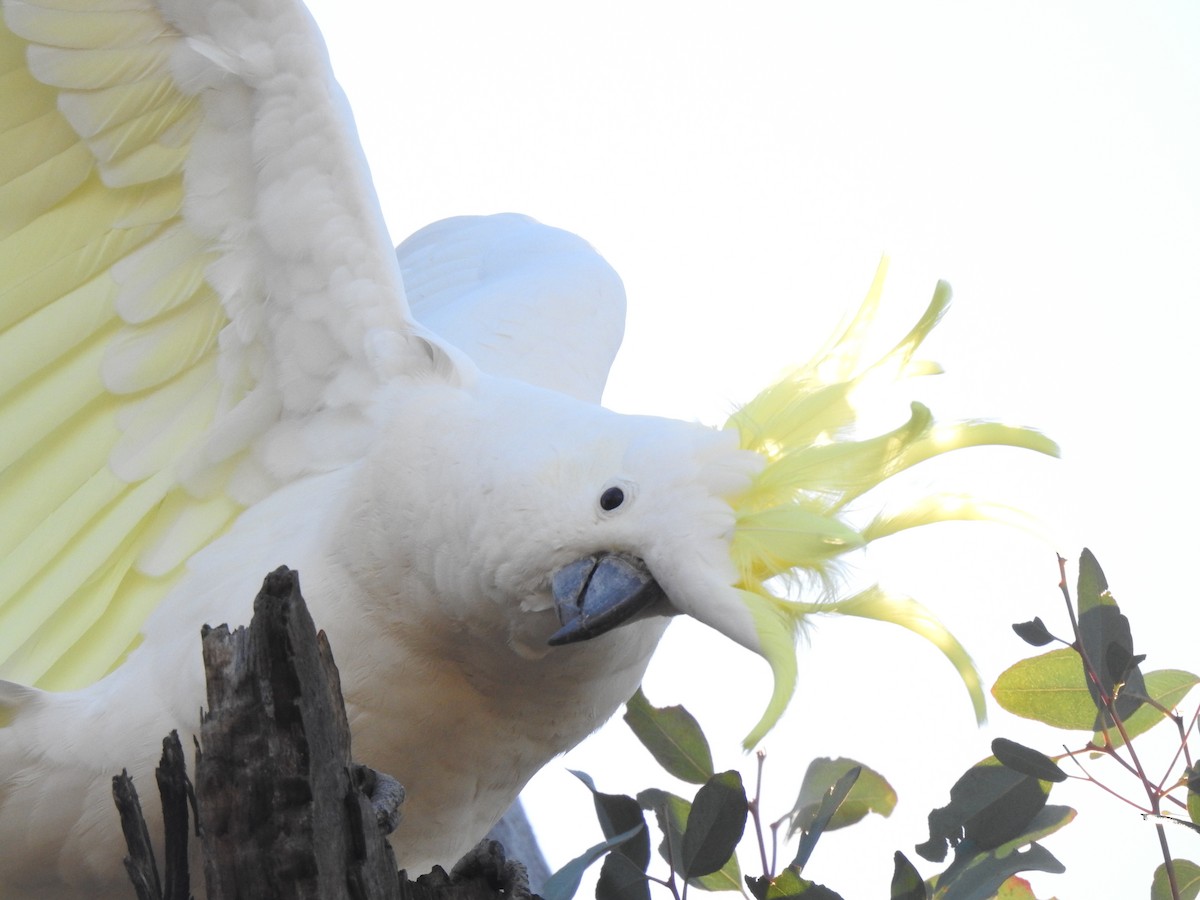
[548,553,670,647]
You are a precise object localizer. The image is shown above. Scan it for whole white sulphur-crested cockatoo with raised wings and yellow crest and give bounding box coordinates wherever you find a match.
[0,0,1052,900]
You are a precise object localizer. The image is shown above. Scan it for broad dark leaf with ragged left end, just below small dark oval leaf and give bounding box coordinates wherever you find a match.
[917,757,1048,868]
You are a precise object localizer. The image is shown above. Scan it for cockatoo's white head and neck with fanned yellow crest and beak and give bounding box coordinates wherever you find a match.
[352,260,1056,744]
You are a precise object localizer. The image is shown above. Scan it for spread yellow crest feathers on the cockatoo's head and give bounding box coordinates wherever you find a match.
[725,259,1057,748]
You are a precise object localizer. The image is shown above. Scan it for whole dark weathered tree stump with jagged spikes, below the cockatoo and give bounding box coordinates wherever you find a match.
[113,566,530,900]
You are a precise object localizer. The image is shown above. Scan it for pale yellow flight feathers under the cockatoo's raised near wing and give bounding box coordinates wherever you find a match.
[0,2,240,689]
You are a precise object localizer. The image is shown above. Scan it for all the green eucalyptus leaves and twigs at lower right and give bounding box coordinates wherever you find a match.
[544,550,1200,900]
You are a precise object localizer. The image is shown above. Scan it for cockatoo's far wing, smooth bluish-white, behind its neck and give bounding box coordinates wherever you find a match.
[396,214,625,403]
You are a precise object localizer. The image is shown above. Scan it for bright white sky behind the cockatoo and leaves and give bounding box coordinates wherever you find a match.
[302,0,1200,899]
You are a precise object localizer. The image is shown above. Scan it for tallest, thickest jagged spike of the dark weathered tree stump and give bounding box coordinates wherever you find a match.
[196,566,400,900]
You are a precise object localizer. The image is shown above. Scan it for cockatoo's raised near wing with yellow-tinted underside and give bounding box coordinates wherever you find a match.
[0,0,454,689]
